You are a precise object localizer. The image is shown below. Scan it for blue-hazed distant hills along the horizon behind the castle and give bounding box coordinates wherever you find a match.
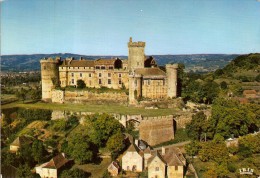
[1,53,239,72]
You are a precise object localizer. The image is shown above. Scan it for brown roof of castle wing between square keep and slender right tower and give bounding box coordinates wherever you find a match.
[135,67,166,78]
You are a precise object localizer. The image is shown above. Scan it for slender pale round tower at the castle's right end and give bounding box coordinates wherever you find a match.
[166,64,178,98]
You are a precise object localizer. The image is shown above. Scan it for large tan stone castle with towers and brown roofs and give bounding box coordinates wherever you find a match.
[40,38,178,104]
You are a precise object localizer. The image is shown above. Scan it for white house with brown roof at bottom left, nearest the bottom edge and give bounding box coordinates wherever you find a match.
[35,153,69,178]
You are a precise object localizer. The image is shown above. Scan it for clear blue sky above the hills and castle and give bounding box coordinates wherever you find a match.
[0,0,260,55]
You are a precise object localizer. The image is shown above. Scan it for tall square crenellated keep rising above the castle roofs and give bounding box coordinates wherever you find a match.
[128,37,145,71]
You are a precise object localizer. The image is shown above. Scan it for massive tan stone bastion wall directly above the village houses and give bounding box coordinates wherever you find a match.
[139,116,174,146]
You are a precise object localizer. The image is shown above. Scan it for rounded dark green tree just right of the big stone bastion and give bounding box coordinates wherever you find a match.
[186,111,207,140]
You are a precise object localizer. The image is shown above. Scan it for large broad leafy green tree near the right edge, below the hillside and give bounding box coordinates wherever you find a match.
[208,98,259,138]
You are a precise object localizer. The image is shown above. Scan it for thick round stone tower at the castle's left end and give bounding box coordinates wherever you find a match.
[40,58,60,101]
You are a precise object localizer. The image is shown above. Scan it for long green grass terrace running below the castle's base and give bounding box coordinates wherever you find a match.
[1,102,177,116]
